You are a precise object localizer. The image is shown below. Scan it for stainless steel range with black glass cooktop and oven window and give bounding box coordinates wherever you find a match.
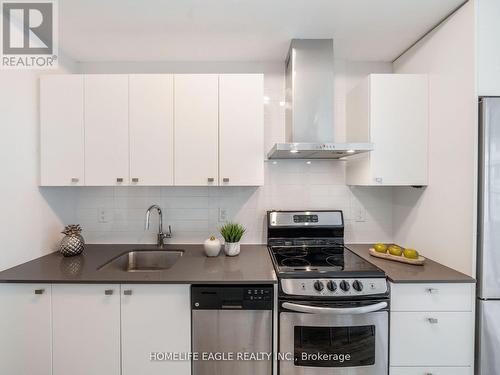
[267,210,389,375]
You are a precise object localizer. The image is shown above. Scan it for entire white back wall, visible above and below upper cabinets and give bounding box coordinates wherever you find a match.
[76,61,392,243]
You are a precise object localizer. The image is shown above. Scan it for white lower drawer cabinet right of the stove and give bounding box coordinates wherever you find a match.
[390,283,474,375]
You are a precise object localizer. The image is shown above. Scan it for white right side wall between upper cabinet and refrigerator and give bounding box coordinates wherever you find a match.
[393,0,474,275]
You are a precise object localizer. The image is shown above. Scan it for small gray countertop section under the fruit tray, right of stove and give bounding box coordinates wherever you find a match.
[346,244,475,283]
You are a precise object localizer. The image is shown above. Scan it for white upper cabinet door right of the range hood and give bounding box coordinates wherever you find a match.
[370,74,429,185]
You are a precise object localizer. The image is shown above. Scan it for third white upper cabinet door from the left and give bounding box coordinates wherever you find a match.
[129,74,174,185]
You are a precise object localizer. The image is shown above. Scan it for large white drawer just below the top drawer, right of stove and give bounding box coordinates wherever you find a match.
[390,312,474,367]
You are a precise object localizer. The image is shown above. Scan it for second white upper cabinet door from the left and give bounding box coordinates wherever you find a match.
[85,74,129,186]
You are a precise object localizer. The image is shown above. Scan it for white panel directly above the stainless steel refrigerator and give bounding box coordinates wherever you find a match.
[476,0,500,96]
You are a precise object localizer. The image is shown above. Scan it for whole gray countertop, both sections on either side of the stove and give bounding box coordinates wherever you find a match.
[0,244,475,284]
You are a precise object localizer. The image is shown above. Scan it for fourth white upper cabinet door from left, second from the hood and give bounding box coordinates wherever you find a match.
[174,74,219,186]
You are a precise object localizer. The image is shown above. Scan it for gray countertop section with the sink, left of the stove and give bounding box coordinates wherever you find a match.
[0,245,277,284]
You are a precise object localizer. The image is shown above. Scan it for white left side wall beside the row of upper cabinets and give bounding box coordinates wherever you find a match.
[0,55,75,270]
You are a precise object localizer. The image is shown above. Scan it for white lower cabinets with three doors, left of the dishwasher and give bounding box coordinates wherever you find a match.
[0,283,191,375]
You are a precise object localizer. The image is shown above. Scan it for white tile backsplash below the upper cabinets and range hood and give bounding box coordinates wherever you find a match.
[77,160,392,243]
